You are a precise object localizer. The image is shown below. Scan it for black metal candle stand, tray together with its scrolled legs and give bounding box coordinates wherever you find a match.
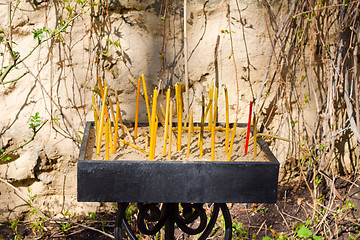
[77,122,279,240]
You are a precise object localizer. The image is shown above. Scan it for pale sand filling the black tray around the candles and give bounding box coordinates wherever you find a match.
[85,126,269,162]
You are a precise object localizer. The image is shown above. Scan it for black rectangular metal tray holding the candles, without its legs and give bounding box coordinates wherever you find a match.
[77,122,279,203]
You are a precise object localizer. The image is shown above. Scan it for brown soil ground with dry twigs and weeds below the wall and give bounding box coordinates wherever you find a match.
[0,178,359,239]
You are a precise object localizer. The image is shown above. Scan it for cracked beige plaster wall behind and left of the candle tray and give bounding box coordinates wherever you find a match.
[0,0,271,221]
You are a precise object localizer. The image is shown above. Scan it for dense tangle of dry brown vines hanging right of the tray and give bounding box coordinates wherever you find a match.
[256,0,360,238]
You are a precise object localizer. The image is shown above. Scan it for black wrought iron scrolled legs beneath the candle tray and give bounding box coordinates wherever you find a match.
[115,202,232,240]
